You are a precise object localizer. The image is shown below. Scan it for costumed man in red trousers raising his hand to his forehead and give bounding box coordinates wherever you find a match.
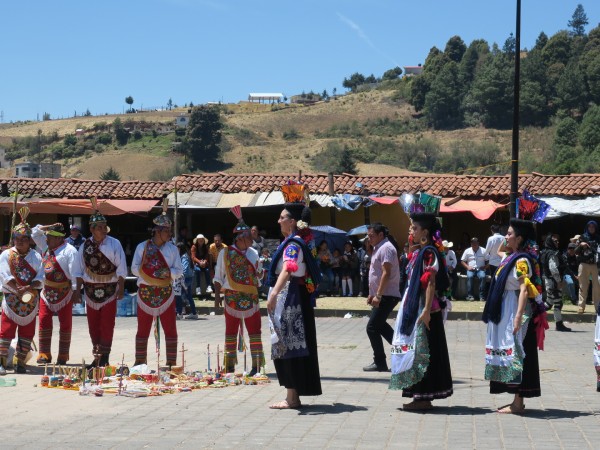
[31,223,80,365]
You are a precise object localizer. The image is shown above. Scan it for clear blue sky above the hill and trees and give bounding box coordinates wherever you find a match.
[0,0,600,123]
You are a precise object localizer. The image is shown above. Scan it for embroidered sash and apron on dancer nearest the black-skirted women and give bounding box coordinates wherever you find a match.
[223,247,259,319]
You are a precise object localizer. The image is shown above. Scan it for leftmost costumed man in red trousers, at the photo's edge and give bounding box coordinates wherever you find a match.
[0,207,44,375]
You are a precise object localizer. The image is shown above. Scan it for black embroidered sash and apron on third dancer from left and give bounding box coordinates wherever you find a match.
[83,238,118,310]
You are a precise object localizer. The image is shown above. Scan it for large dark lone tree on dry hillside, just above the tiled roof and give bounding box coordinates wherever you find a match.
[181,105,223,169]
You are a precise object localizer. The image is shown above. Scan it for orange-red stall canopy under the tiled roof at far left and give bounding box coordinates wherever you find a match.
[0,198,158,216]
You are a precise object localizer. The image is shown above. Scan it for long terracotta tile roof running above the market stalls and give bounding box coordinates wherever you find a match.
[0,173,600,199]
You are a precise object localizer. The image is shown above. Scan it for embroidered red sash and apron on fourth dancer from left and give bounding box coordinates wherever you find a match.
[138,239,175,317]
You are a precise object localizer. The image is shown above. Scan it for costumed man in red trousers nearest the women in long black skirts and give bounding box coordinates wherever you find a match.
[213,207,265,376]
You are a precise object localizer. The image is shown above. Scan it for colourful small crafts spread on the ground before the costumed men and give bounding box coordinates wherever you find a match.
[39,344,270,397]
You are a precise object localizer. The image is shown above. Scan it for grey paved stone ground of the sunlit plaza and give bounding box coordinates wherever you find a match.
[0,316,600,450]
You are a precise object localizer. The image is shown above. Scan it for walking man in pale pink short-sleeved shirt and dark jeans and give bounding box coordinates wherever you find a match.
[363,223,400,372]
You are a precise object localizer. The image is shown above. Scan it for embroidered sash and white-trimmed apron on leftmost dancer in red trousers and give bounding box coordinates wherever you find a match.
[2,249,39,326]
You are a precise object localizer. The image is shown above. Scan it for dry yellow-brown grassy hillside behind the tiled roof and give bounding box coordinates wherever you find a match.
[0,90,552,180]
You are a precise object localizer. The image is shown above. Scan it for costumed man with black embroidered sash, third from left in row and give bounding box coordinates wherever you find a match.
[73,199,127,367]
